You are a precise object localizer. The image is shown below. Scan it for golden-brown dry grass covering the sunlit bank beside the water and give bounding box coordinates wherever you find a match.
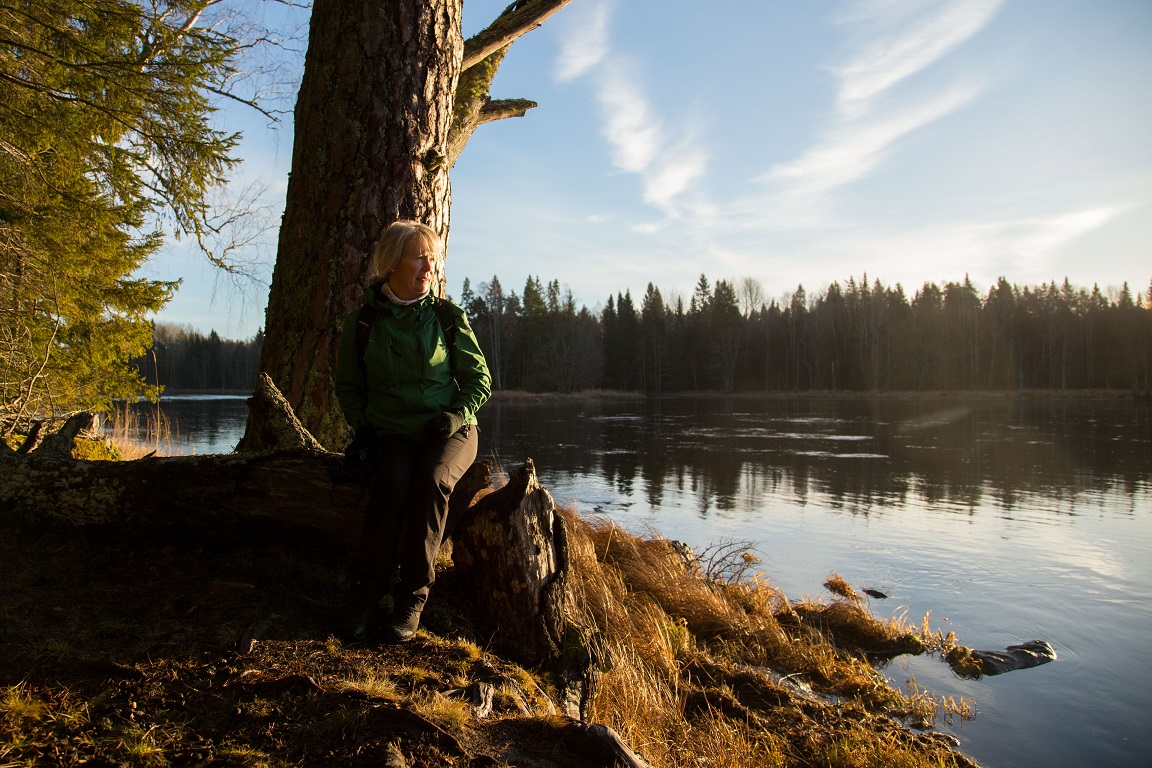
[550,511,971,768]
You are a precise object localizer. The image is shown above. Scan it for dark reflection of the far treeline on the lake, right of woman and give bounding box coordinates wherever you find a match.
[480,398,1152,516]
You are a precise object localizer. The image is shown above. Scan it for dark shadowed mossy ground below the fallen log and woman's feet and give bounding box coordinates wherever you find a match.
[0,526,602,768]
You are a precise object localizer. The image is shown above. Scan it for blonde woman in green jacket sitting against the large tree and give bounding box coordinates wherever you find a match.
[336,221,492,642]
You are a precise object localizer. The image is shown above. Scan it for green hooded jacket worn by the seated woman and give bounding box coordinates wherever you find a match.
[336,284,492,438]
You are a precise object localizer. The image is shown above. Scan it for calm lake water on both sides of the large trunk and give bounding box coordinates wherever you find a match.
[128,398,1152,768]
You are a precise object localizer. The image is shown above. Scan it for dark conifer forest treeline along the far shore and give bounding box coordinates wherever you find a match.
[144,275,1152,393]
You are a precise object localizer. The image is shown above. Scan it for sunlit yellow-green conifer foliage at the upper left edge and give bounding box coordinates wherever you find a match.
[0,0,245,432]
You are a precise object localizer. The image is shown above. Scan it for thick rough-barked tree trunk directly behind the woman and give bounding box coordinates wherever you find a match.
[260,0,463,449]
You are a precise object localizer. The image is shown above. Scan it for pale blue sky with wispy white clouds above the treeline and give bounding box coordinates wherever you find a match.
[145,0,1152,337]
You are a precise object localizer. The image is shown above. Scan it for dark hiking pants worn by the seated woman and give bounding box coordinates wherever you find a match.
[353,426,478,608]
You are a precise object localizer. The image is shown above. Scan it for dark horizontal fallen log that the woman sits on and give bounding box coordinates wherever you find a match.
[0,377,472,548]
